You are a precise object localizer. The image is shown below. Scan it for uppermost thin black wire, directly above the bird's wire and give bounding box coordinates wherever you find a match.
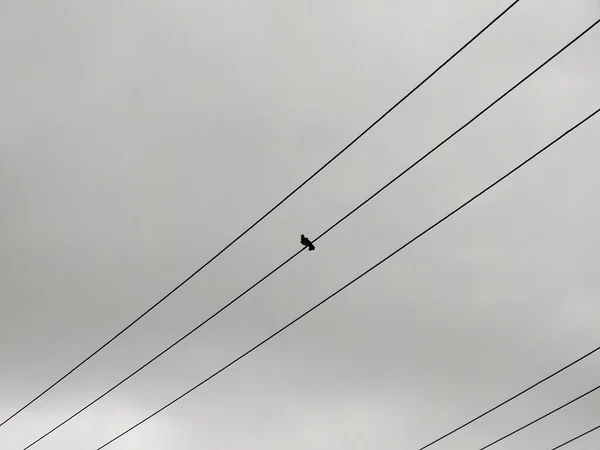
[0,0,520,427]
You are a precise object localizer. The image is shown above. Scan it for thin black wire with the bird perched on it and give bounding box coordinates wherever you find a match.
[23,15,600,450]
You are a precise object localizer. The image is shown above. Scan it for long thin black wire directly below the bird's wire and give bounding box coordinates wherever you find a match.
[96,104,600,450]
